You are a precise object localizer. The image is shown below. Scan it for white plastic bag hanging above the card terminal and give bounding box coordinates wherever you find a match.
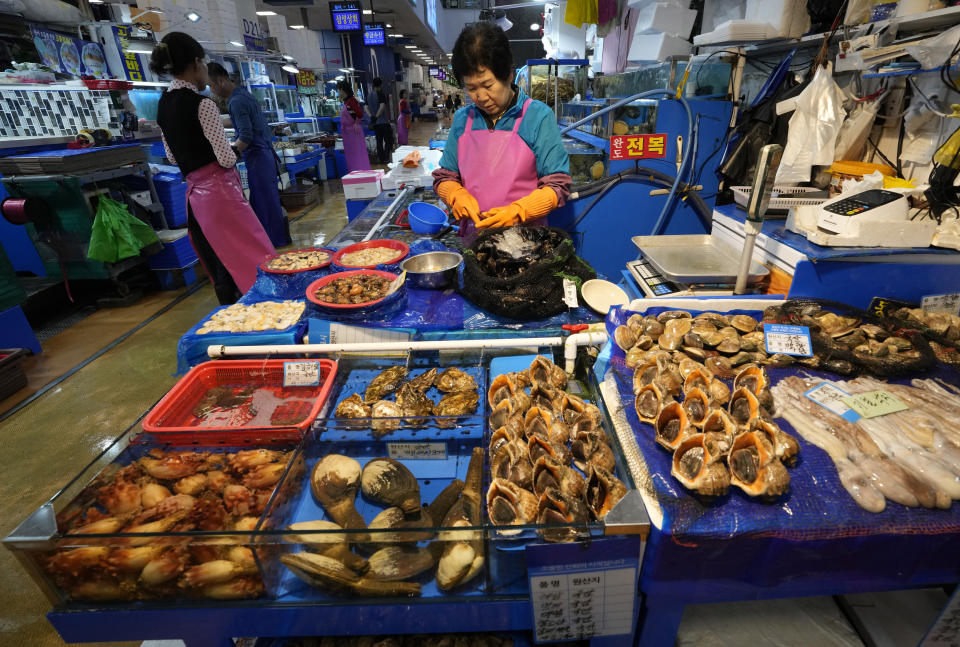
[776,66,845,184]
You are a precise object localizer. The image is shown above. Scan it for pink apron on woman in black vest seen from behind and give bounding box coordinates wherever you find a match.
[187,162,276,293]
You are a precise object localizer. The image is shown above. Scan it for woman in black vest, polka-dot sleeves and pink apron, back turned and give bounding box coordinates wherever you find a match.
[150,32,276,305]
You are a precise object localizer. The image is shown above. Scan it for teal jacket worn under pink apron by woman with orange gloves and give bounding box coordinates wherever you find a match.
[433,88,572,205]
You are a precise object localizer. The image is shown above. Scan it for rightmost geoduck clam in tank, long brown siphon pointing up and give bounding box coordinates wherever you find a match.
[436,447,484,591]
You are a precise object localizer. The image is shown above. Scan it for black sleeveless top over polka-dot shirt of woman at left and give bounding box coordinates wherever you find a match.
[157,88,217,176]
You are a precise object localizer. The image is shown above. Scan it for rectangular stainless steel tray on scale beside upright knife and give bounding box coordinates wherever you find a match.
[632,234,770,283]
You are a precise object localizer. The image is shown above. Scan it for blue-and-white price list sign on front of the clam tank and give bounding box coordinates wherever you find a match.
[527,539,639,643]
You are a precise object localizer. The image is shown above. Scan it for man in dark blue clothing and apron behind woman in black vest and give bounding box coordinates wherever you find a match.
[207,63,291,247]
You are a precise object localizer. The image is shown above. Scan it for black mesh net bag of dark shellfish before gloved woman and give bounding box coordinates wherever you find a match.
[460,227,597,321]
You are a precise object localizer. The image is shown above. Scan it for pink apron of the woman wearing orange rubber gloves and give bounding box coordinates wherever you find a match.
[457,98,546,243]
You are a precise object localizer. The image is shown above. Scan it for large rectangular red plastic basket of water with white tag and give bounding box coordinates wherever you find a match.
[143,359,337,444]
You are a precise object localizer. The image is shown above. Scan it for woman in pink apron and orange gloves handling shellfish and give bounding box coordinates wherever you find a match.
[433,22,572,243]
